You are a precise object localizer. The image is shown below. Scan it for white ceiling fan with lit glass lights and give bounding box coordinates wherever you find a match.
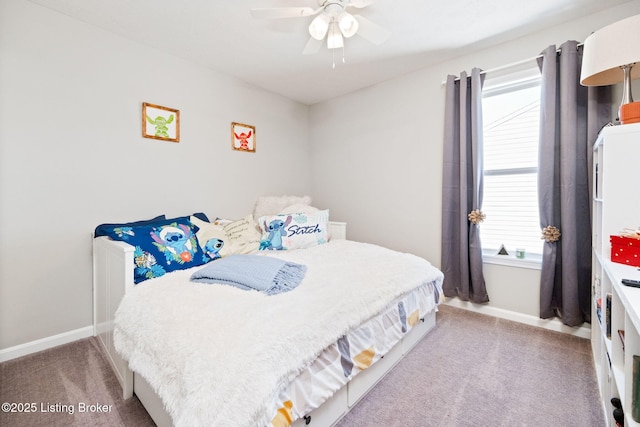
[251,0,391,55]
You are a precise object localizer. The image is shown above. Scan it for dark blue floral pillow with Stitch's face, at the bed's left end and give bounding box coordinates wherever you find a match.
[108,218,210,283]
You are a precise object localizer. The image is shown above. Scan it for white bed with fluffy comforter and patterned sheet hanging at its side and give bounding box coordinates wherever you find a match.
[93,201,443,427]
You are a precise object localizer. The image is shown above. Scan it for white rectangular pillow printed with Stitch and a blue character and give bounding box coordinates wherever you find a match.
[258,210,329,250]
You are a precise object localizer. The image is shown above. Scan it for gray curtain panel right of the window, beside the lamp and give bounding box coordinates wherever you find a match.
[538,41,611,326]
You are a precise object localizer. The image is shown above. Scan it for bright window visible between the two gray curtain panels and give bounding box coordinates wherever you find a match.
[480,69,542,260]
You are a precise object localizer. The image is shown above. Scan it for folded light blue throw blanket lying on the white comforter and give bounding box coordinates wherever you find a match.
[191,255,307,295]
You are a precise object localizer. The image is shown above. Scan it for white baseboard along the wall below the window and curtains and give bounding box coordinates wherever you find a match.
[445,298,591,339]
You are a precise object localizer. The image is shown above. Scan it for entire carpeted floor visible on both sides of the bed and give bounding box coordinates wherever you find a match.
[0,306,605,427]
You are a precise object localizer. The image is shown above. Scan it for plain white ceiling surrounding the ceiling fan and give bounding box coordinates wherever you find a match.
[30,0,630,104]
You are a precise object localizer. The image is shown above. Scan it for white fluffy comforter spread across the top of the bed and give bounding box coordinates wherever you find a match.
[114,240,442,426]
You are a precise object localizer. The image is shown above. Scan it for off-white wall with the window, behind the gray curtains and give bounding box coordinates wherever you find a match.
[310,1,640,328]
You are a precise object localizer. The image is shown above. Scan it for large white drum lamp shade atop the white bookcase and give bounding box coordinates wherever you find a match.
[580,15,640,86]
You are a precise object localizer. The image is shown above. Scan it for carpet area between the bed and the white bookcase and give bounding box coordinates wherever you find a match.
[338,306,606,427]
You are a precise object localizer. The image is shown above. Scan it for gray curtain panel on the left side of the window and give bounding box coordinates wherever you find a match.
[441,68,489,303]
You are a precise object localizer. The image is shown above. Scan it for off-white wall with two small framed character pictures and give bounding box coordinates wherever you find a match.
[0,0,310,350]
